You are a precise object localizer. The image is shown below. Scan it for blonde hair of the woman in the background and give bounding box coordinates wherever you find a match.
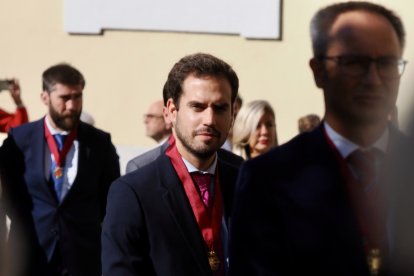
[232,100,277,159]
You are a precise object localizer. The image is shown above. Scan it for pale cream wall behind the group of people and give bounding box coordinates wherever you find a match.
[0,0,414,149]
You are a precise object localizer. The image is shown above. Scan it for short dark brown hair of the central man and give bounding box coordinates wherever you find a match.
[163,53,239,107]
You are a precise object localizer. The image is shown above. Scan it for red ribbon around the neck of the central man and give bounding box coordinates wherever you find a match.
[166,141,223,251]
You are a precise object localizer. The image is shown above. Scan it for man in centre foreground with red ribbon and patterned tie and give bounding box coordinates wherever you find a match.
[102,54,242,276]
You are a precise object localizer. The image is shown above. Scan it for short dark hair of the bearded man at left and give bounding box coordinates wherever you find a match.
[42,63,86,93]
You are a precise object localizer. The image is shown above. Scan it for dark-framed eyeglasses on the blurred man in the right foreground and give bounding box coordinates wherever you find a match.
[319,55,407,79]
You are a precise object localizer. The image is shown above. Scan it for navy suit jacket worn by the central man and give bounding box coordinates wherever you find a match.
[102,150,243,276]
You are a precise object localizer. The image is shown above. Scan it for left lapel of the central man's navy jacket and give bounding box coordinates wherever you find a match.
[155,154,209,271]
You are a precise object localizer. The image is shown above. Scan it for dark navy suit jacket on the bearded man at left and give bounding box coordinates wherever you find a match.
[0,119,120,275]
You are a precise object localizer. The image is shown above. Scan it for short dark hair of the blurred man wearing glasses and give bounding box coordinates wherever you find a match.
[310,1,405,57]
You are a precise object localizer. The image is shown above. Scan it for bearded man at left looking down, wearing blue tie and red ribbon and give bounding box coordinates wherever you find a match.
[0,64,120,276]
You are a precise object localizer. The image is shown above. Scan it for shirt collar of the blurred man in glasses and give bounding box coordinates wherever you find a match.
[324,121,390,158]
